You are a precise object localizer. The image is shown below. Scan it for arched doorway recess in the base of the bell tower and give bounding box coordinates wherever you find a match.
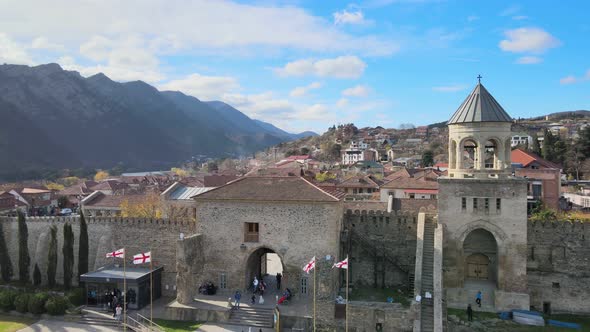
[463,228,498,284]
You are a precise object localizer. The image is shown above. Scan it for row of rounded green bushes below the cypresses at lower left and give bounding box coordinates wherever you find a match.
[0,290,74,315]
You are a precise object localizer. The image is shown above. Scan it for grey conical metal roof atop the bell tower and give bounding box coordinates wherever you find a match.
[447,83,512,124]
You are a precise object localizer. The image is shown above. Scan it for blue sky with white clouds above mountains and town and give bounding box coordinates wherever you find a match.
[0,0,590,133]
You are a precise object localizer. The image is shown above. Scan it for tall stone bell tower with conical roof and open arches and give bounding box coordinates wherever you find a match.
[438,76,529,311]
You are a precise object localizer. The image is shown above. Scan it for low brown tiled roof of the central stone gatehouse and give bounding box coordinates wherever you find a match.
[194,176,343,202]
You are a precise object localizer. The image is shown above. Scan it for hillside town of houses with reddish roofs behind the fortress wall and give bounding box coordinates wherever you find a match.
[0,112,590,219]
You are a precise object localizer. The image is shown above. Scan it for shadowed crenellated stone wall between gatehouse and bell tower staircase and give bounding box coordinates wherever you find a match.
[341,210,417,287]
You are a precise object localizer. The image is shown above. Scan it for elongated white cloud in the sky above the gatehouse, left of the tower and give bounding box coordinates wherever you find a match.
[275,55,367,79]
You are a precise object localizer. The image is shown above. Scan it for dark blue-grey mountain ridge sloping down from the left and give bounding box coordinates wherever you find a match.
[0,64,310,181]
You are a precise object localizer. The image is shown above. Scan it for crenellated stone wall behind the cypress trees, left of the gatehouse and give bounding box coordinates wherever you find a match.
[0,217,195,296]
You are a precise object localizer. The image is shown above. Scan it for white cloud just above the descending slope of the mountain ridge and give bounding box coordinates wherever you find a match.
[158,73,240,100]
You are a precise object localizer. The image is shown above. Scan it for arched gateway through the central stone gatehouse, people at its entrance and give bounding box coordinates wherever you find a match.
[245,247,284,289]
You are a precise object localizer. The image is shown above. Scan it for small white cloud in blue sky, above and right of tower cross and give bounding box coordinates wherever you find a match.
[499,27,561,53]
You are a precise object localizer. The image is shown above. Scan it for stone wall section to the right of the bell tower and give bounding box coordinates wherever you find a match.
[527,221,590,313]
